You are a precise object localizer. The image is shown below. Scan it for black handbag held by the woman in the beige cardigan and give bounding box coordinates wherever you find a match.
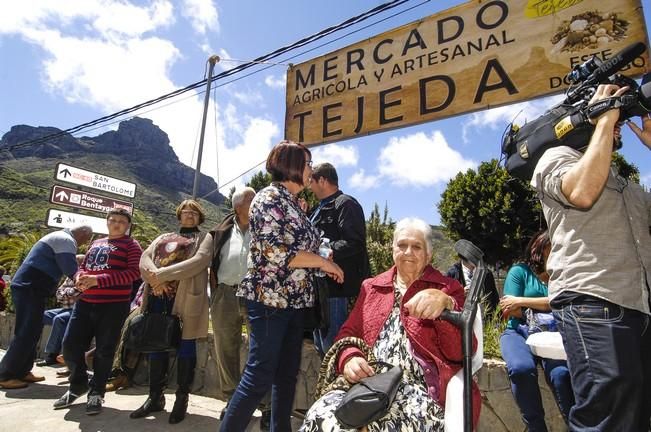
[124,311,182,353]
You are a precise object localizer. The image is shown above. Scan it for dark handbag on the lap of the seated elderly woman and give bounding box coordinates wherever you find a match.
[335,362,402,429]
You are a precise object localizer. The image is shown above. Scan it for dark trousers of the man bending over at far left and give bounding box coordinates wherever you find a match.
[0,282,51,380]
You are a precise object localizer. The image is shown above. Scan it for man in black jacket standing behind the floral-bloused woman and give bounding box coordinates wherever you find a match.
[310,162,370,354]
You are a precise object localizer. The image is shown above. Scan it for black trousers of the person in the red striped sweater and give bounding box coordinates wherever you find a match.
[63,300,129,396]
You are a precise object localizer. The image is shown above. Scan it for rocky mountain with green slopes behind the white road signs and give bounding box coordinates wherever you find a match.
[0,117,225,234]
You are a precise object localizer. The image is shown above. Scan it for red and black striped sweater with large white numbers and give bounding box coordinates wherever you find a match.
[79,236,142,303]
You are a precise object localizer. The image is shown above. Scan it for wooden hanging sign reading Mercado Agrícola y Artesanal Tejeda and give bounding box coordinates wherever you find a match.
[285,0,649,145]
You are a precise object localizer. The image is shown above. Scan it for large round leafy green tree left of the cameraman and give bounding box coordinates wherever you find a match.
[438,159,544,265]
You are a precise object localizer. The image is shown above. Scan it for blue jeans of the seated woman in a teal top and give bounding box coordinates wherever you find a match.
[500,327,574,432]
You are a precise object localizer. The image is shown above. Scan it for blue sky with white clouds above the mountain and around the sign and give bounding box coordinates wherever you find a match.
[0,0,651,225]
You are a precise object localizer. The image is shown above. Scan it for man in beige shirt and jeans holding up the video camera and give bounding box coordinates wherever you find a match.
[531,84,651,432]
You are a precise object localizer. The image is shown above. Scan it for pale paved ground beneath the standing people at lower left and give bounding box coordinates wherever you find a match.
[0,350,300,432]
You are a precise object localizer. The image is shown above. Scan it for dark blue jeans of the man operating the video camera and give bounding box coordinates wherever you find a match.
[553,296,651,432]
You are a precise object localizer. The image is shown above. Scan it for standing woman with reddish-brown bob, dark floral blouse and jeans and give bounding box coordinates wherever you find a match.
[220,141,344,432]
